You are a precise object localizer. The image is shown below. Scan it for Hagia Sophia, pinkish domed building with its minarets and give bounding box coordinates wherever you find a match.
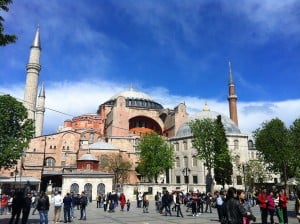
[1,27,273,200]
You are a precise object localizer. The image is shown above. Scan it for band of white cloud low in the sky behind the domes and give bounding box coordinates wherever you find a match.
[0,80,300,134]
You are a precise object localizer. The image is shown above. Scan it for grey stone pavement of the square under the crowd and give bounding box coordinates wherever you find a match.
[0,201,298,224]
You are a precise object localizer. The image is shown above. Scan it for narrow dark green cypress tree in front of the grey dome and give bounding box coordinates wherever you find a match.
[214,115,233,188]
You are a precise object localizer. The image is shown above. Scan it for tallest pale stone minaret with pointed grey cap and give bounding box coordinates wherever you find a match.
[24,26,41,134]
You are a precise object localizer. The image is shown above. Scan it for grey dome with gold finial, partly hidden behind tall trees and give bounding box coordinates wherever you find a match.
[176,107,241,137]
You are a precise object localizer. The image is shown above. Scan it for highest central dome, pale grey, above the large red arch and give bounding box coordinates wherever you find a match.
[104,88,163,109]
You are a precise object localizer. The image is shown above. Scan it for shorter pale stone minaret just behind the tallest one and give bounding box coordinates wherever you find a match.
[35,83,45,137]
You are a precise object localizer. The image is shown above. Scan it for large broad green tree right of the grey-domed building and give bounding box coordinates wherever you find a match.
[254,118,294,190]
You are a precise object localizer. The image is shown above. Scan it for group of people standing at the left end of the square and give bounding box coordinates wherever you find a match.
[0,191,88,224]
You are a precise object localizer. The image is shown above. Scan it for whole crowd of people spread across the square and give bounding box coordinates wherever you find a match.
[0,187,300,224]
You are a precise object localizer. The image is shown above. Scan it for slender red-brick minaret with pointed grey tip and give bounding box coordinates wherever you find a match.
[228,61,239,126]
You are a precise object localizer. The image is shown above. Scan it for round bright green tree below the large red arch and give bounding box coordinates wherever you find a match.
[137,133,174,183]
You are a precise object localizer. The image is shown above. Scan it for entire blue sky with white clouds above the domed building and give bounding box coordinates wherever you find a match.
[0,0,300,133]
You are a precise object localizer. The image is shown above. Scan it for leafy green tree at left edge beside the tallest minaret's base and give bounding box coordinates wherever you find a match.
[0,95,34,168]
